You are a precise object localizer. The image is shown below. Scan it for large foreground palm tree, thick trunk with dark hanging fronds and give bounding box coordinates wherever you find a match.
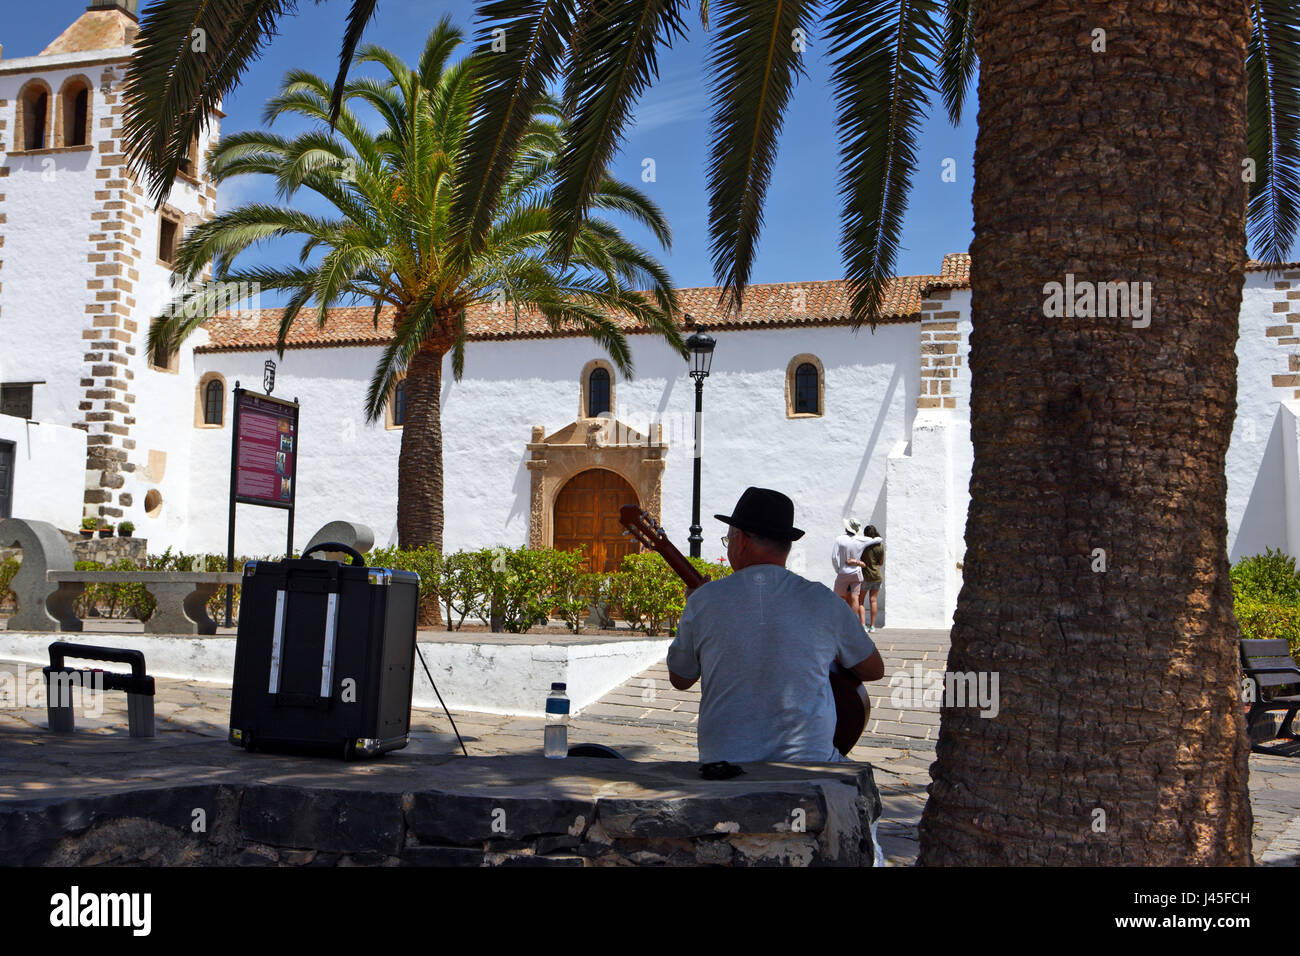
[129,0,1300,864]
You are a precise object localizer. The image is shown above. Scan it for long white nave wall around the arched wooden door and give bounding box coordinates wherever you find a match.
[188,324,919,583]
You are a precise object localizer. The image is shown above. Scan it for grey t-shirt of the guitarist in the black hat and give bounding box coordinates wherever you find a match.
[668,564,876,763]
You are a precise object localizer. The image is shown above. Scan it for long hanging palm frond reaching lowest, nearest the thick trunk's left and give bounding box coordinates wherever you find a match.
[829,0,939,328]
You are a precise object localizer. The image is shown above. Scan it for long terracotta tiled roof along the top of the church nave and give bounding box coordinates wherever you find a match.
[195,276,939,352]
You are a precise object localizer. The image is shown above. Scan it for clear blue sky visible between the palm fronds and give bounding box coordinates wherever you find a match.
[0,0,975,287]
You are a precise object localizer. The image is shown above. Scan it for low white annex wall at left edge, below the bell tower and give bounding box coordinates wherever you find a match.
[0,415,86,531]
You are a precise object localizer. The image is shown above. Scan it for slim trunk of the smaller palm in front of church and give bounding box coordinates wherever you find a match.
[398,341,447,553]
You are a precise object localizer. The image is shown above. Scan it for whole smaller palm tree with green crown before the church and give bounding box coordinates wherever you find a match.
[150,20,685,550]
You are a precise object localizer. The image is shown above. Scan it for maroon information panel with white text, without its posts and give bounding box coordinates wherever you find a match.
[235,392,298,507]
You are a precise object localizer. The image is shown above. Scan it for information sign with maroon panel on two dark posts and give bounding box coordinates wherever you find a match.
[226,381,299,627]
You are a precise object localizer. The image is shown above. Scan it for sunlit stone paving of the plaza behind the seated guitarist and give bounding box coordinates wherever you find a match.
[0,630,1300,866]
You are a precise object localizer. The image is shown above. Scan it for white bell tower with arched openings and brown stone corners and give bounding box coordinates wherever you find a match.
[0,0,217,535]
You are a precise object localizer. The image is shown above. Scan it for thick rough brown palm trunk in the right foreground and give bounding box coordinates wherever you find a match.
[920,0,1251,865]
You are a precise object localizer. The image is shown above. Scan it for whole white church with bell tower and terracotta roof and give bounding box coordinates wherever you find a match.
[0,0,1300,627]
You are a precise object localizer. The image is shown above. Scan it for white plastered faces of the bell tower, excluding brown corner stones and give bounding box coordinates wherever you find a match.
[0,47,218,538]
